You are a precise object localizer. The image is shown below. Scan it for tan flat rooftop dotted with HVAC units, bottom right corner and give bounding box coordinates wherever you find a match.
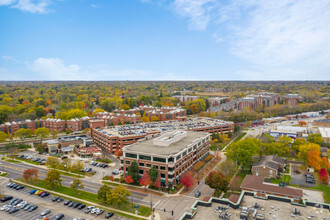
[194,196,330,220]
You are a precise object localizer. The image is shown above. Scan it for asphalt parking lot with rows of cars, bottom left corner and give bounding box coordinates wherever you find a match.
[0,179,125,220]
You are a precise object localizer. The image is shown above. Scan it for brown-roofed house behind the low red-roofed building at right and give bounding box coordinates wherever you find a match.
[251,155,286,178]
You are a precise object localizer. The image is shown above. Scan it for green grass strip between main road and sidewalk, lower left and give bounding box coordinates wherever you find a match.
[18,178,151,218]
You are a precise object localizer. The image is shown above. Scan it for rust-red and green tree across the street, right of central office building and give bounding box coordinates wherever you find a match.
[205,171,229,193]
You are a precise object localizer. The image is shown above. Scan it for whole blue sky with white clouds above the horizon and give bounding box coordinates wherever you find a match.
[0,0,330,80]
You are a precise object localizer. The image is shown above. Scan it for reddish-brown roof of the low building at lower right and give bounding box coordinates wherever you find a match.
[241,175,303,198]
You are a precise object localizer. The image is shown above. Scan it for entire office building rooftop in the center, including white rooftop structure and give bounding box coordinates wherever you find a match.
[123,131,209,156]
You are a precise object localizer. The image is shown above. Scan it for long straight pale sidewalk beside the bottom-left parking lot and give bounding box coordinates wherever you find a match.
[12,180,151,219]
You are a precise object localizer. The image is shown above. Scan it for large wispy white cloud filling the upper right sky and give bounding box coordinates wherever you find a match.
[168,0,330,79]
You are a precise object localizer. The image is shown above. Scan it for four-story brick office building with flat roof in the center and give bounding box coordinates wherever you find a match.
[121,130,210,187]
